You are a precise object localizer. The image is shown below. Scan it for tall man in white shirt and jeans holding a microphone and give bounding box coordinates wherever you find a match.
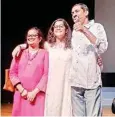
[71,3,108,116]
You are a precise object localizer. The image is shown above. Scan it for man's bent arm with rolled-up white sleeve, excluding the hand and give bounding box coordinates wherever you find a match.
[82,24,108,55]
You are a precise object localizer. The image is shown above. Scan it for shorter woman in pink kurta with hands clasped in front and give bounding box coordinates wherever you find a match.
[10,27,49,116]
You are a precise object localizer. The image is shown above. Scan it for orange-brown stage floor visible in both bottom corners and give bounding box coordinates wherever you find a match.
[1,104,115,116]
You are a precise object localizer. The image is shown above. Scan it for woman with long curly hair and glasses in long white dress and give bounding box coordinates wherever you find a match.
[45,19,71,116]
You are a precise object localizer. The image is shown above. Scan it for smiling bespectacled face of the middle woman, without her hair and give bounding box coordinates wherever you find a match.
[54,21,66,40]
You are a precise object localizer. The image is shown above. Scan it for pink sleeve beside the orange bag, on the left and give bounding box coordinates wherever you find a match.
[9,58,20,86]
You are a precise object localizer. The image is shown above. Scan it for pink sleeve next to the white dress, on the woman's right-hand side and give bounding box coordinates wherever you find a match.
[36,52,49,92]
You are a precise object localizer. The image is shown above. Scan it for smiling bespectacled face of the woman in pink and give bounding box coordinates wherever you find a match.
[27,29,41,46]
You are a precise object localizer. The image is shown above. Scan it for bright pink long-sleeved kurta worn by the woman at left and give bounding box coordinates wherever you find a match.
[10,49,49,116]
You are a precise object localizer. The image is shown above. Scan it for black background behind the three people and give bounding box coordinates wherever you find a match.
[1,0,115,102]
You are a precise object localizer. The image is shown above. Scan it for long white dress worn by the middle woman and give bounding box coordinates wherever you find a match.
[45,43,71,116]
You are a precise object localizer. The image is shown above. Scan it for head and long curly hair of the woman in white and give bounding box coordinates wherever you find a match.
[47,18,72,49]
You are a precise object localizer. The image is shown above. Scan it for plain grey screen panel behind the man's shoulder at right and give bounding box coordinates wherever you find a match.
[95,0,115,73]
